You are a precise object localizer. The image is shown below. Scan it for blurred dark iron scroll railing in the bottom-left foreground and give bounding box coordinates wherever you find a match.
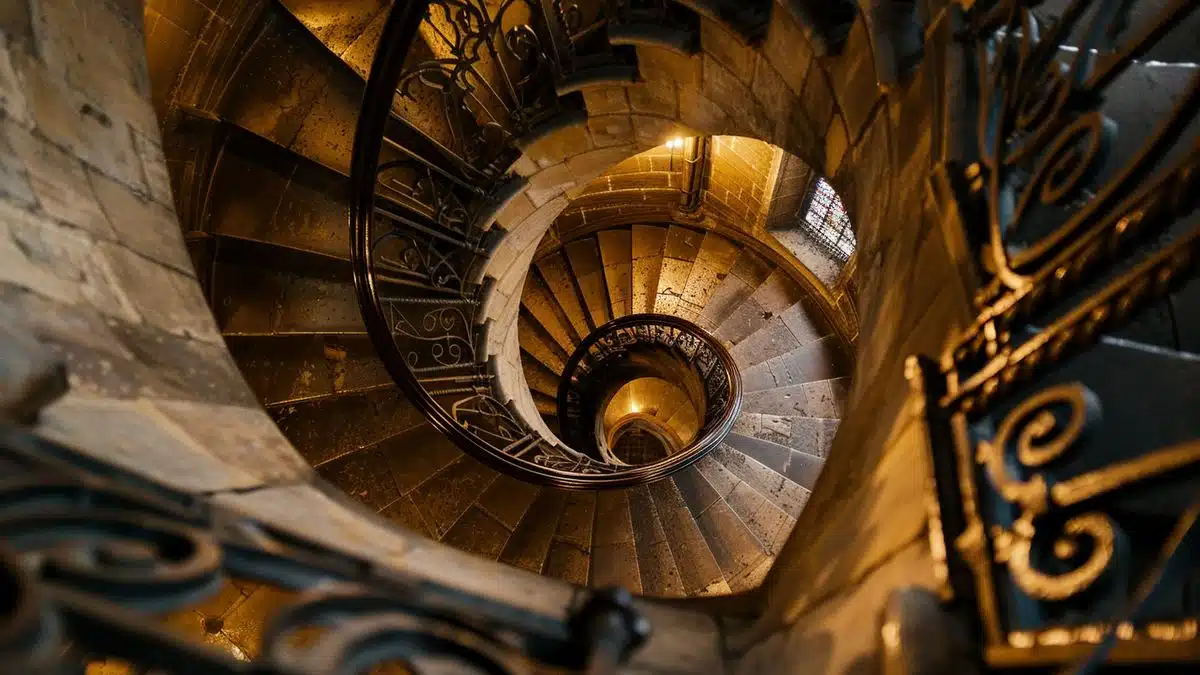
[0,424,649,675]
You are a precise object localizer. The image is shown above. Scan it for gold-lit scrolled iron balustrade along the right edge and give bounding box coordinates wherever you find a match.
[893,0,1200,673]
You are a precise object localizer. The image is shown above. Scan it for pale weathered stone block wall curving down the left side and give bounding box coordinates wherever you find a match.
[0,0,719,671]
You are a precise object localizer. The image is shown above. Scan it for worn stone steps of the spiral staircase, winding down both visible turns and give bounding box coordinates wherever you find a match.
[166,2,864,597]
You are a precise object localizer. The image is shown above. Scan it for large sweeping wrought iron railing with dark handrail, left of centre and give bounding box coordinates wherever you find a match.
[350,0,734,488]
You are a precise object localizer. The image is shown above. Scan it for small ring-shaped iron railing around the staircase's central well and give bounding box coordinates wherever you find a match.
[558,313,742,466]
